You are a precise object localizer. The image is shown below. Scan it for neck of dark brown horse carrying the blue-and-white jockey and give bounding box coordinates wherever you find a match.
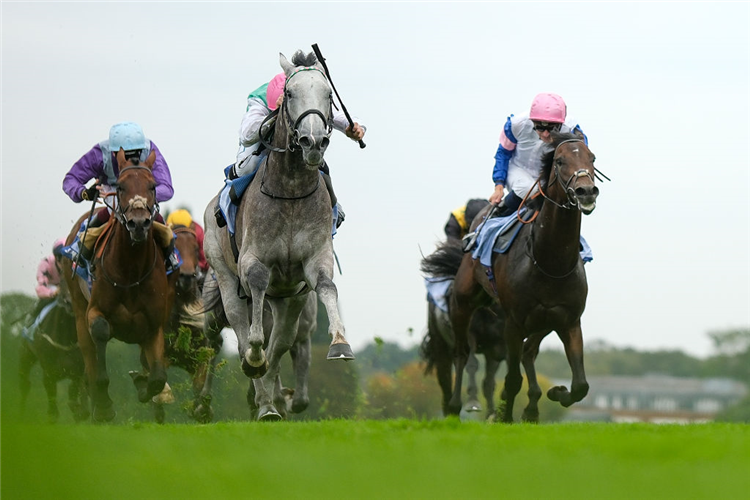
[531,188,581,273]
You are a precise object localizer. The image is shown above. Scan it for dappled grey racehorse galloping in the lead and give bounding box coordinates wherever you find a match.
[204,51,354,420]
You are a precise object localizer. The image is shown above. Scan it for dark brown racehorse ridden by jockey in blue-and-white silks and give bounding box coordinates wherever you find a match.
[449,134,599,422]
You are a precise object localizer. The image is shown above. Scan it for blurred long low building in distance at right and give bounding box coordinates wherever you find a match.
[555,375,748,423]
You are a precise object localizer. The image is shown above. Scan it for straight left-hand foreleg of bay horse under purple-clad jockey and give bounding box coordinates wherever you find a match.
[87,308,115,422]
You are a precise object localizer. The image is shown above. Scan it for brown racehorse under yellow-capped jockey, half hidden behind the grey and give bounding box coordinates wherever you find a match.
[131,225,221,423]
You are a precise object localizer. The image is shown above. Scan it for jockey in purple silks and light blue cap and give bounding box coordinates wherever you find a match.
[63,122,174,268]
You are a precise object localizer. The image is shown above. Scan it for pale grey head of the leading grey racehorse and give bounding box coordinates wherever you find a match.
[279,51,333,169]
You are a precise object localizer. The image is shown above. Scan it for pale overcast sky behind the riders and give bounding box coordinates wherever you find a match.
[0,1,750,356]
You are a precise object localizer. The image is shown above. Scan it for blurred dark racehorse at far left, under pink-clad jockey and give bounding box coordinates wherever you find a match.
[18,257,90,422]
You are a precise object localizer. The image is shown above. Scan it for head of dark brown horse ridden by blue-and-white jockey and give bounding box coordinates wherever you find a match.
[542,133,599,215]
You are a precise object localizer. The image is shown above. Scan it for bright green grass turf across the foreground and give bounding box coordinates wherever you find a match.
[0,419,750,500]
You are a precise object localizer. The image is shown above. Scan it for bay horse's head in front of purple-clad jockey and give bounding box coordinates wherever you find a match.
[115,148,159,244]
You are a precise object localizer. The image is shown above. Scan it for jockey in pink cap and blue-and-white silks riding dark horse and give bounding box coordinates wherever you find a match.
[490,93,588,216]
